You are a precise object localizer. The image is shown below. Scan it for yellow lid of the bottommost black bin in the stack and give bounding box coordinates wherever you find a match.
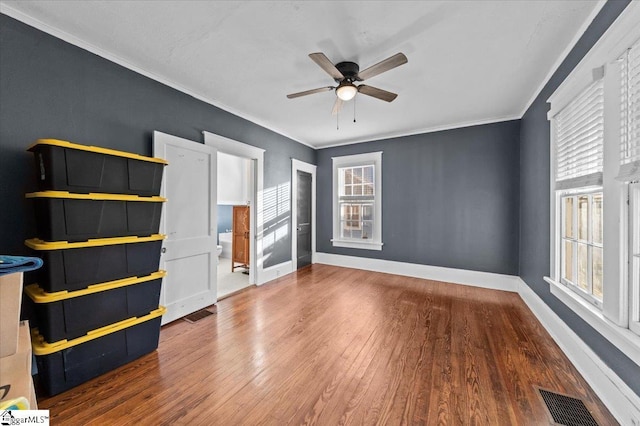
[31,306,167,356]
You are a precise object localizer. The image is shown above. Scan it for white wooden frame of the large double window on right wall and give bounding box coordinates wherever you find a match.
[544,2,640,365]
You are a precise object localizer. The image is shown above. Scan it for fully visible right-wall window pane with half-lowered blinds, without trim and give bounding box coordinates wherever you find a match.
[553,79,604,307]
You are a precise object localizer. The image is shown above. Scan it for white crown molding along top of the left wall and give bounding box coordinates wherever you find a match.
[0,3,316,149]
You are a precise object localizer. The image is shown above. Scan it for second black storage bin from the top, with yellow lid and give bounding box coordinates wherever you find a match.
[26,191,166,242]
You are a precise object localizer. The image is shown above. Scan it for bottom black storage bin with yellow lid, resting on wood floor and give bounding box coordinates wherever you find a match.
[31,307,166,395]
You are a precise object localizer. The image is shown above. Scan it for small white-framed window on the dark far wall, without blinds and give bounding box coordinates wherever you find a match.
[332,152,382,250]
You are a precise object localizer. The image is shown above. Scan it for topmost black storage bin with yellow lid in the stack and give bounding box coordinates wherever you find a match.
[29,139,167,196]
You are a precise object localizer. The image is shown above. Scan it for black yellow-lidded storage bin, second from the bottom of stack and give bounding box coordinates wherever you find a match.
[24,271,165,342]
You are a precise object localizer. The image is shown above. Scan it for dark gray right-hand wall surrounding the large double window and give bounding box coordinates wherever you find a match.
[520,0,640,395]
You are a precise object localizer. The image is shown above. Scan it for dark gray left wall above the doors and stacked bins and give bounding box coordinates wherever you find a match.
[0,15,316,266]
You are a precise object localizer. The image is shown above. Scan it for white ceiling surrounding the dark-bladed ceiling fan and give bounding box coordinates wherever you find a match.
[1,0,603,147]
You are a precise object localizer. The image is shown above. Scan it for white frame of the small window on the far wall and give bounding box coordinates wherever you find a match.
[331,151,383,250]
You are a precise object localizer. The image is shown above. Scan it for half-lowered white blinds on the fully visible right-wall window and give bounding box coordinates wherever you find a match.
[554,80,604,190]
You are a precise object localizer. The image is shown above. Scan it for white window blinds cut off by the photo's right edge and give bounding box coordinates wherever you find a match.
[618,38,640,181]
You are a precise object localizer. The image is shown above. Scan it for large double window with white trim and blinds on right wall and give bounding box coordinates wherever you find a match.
[545,3,640,364]
